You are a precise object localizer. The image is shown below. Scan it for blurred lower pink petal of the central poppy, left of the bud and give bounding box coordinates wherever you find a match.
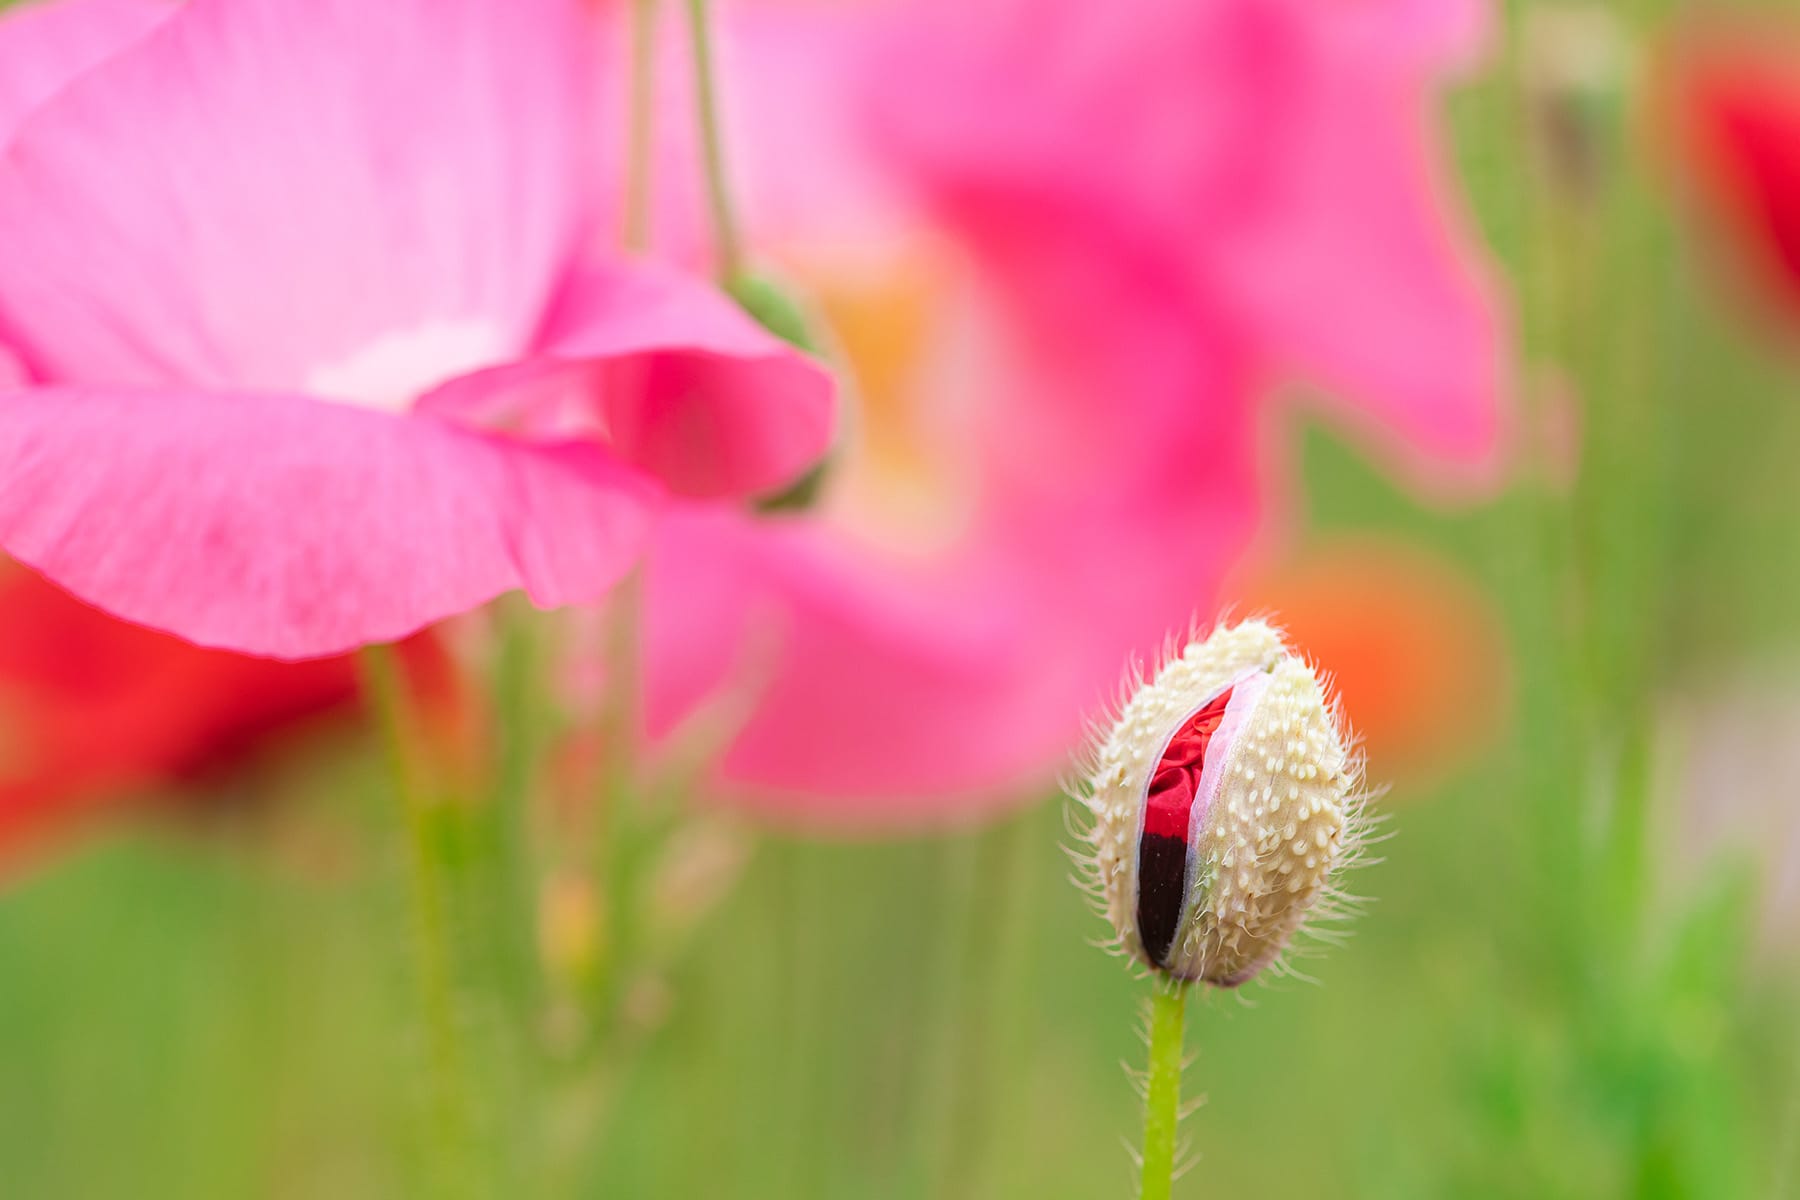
[646,509,1051,826]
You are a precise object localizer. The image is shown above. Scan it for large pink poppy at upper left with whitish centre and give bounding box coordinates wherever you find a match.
[0,0,832,658]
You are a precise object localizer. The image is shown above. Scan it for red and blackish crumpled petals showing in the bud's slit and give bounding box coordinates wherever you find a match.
[1138,687,1231,966]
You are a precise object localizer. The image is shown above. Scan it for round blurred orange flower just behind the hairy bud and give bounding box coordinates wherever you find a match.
[1231,536,1510,792]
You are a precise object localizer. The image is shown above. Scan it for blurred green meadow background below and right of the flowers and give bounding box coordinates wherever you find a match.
[0,4,1800,1200]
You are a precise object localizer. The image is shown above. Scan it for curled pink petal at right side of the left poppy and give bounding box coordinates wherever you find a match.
[419,261,835,497]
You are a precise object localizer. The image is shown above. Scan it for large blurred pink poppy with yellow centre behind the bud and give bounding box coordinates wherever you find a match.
[633,0,1503,829]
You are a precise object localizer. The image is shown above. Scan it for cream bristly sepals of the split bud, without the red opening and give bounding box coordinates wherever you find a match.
[1075,621,1366,986]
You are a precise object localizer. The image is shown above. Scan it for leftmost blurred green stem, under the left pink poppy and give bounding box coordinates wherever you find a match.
[358,646,472,1180]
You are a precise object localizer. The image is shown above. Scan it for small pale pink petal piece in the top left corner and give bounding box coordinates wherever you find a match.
[0,0,175,146]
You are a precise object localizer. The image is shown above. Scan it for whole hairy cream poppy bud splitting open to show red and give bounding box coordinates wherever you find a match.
[1069,621,1370,988]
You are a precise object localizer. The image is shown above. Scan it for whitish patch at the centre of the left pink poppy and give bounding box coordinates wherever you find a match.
[306,317,517,412]
